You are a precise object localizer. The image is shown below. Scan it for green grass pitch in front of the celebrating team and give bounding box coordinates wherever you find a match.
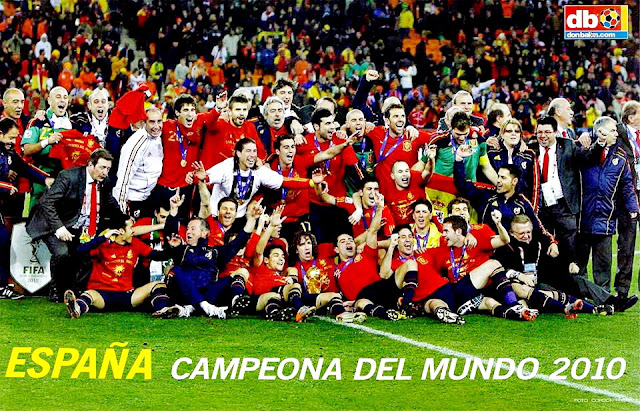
[0,240,640,410]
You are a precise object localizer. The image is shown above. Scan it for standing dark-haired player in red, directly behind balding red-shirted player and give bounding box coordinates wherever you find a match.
[368,104,431,195]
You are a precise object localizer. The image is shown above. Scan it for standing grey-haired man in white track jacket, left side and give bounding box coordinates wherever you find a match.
[113,106,164,219]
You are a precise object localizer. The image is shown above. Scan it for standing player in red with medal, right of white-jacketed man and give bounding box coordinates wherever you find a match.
[153,94,226,217]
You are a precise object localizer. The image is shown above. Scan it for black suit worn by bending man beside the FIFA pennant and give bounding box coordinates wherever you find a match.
[26,167,127,297]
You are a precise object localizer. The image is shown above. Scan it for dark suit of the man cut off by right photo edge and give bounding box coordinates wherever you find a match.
[614,123,640,296]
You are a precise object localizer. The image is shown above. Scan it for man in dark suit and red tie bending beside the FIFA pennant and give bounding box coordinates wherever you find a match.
[27,149,127,302]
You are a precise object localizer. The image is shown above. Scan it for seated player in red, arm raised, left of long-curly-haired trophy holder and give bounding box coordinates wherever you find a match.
[248,207,315,322]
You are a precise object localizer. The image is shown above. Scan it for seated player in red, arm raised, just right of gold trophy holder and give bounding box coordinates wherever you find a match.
[334,193,406,321]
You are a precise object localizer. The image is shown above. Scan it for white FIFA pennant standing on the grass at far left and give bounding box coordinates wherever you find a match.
[10,223,51,294]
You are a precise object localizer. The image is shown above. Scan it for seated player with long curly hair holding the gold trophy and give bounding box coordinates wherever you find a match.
[293,230,367,323]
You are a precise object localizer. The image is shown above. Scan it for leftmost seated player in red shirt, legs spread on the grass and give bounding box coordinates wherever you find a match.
[64,220,174,318]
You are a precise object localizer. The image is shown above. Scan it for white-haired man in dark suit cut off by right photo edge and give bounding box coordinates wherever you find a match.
[614,100,640,298]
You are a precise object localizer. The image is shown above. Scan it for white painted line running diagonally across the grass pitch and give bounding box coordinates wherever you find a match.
[317,317,640,405]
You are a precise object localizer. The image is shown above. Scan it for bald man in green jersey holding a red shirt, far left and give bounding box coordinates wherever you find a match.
[21,87,71,207]
